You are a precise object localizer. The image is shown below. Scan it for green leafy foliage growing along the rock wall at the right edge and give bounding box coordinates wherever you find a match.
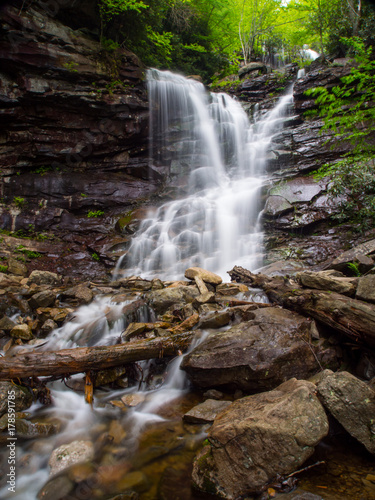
[306,37,375,230]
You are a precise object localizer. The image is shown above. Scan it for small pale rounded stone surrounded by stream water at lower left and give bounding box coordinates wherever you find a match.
[48,441,94,476]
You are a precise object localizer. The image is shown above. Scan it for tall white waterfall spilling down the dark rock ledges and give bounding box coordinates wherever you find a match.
[115,69,292,279]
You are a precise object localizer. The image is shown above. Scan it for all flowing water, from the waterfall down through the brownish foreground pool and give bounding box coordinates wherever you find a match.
[0,70,298,500]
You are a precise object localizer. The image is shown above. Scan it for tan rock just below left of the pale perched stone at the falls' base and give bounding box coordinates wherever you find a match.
[147,286,199,314]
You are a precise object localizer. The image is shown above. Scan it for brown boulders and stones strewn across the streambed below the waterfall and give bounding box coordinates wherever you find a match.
[0,240,375,499]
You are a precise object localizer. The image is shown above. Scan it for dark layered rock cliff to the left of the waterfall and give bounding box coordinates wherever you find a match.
[0,0,164,278]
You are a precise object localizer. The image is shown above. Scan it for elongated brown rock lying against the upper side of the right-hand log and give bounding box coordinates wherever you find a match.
[297,271,358,297]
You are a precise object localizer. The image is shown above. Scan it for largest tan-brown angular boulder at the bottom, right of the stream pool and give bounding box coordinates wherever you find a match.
[193,379,328,500]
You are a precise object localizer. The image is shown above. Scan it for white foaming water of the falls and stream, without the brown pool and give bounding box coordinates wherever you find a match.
[0,72,292,500]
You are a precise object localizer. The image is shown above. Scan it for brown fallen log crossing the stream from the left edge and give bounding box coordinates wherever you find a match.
[0,332,194,380]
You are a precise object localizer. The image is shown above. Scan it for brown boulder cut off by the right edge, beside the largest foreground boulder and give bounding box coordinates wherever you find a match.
[317,370,375,454]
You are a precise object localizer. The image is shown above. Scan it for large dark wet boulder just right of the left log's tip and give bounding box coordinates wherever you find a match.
[181,307,319,391]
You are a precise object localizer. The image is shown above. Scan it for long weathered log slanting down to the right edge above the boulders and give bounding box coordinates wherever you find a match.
[228,266,375,347]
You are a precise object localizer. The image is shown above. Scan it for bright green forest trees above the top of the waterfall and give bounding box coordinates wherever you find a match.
[98,0,375,82]
